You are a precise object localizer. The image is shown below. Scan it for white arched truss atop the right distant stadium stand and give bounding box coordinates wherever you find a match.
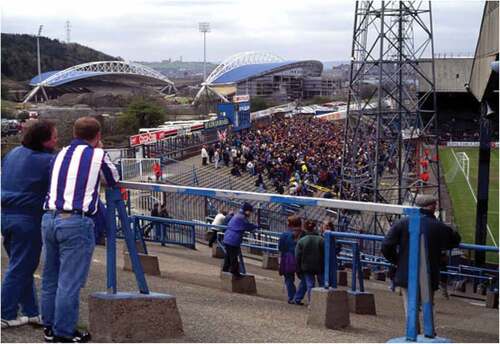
[205,51,285,84]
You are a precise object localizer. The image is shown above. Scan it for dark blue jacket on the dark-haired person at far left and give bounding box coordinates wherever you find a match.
[2,146,54,217]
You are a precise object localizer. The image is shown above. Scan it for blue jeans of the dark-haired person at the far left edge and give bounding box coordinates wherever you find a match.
[2,212,42,320]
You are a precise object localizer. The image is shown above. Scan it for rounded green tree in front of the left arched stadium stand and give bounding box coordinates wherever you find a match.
[120,97,165,132]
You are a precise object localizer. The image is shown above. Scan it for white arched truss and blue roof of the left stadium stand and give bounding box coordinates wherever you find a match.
[23,61,176,103]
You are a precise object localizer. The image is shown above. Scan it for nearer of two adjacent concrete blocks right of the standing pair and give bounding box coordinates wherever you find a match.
[307,288,350,330]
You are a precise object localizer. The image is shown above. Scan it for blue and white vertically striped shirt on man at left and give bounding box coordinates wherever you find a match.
[44,139,120,215]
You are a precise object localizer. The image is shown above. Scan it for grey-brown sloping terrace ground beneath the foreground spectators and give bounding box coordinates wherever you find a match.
[0,242,499,342]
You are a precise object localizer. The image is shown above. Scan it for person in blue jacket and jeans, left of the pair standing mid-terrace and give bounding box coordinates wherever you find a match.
[278,215,306,305]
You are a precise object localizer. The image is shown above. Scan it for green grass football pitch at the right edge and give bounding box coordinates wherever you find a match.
[440,147,499,254]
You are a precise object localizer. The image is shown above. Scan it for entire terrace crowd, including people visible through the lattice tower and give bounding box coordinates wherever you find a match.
[201,116,396,200]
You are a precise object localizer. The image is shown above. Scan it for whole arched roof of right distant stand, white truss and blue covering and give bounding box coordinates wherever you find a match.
[205,51,323,85]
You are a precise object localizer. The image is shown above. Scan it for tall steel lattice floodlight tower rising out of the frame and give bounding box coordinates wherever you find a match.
[341,1,441,232]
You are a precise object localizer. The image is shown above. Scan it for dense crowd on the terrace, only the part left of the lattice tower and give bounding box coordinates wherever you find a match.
[202,116,350,195]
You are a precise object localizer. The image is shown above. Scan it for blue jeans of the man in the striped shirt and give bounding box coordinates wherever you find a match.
[41,212,95,337]
